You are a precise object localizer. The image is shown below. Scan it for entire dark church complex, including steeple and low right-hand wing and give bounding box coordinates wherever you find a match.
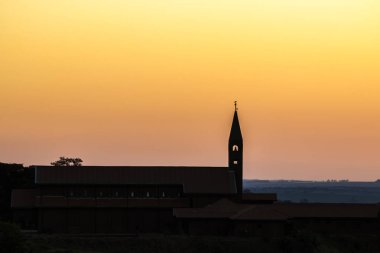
[11,102,379,235]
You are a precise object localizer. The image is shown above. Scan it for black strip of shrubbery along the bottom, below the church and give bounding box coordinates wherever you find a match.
[0,223,380,253]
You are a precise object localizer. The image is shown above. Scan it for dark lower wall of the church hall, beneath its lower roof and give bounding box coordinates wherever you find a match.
[35,208,178,234]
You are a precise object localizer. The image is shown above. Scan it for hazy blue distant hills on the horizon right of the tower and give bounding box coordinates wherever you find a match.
[244,180,380,203]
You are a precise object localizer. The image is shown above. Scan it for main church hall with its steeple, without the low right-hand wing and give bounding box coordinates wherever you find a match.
[12,103,243,233]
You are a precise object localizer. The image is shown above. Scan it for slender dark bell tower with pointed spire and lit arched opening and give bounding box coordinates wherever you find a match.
[228,101,243,194]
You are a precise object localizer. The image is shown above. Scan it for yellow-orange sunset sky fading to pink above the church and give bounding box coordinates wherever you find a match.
[0,0,380,180]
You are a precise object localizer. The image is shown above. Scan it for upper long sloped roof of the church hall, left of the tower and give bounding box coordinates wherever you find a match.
[35,166,236,194]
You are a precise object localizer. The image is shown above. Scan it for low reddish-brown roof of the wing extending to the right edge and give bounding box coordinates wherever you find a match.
[174,199,380,220]
